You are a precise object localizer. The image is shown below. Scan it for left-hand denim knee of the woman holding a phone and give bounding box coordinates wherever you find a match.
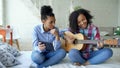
[31,51,45,64]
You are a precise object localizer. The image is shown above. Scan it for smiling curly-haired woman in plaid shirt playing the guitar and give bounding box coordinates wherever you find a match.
[60,9,116,65]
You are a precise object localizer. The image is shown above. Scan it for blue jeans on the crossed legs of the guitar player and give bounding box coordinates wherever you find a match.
[69,48,113,64]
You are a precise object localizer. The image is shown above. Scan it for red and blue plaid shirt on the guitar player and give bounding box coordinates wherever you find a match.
[79,24,100,58]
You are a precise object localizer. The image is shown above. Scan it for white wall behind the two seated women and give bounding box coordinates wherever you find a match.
[6,0,120,48]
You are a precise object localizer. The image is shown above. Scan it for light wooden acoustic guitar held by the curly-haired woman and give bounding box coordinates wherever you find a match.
[61,31,120,51]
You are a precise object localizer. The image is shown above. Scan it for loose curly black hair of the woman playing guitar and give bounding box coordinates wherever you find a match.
[69,9,93,33]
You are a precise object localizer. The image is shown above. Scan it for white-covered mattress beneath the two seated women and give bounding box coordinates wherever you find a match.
[9,48,120,68]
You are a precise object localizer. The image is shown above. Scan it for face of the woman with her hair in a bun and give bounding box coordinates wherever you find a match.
[42,16,55,31]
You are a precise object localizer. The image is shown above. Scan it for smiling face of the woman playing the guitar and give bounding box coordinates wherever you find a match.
[77,14,88,29]
